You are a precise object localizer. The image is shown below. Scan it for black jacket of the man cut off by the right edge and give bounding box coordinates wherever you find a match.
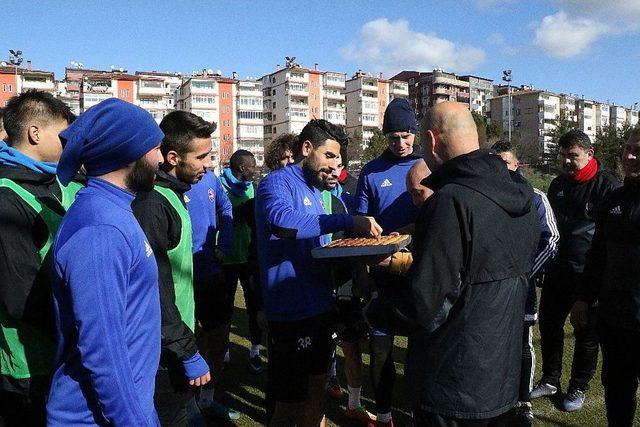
[578,179,640,331]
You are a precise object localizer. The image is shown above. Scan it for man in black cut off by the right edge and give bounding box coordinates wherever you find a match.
[571,128,640,427]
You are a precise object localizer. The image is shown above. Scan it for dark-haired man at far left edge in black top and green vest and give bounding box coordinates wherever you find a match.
[0,91,75,425]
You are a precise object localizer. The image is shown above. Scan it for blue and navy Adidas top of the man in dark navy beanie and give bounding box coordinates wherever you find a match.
[355,150,420,234]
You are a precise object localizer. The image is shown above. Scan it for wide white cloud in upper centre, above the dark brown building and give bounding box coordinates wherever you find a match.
[340,18,486,75]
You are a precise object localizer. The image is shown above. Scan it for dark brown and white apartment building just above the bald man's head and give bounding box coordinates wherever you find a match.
[392,69,493,120]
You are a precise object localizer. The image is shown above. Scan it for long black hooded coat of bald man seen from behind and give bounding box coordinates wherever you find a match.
[368,150,540,419]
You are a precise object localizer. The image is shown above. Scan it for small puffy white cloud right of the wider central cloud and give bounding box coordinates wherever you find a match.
[533,11,610,59]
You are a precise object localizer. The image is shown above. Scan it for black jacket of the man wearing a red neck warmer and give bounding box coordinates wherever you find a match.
[547,165,620,273]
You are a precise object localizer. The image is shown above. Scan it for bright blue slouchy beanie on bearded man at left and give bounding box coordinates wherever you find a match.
[57,98,164,185]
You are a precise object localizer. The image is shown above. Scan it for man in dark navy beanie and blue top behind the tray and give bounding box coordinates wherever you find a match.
[355,98,420,426]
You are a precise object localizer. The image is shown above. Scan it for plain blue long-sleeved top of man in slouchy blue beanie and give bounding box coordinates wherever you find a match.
[47,178,160,426]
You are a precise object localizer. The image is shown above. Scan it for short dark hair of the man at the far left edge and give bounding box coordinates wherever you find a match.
[2,89,76,145]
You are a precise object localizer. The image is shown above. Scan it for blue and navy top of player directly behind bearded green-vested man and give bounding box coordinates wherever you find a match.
[185,171,233,278]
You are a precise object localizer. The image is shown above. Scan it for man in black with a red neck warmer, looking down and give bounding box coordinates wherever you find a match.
[531,130,620,411]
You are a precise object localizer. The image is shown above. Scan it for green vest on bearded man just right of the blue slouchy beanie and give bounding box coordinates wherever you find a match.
[154,185,196,331]
